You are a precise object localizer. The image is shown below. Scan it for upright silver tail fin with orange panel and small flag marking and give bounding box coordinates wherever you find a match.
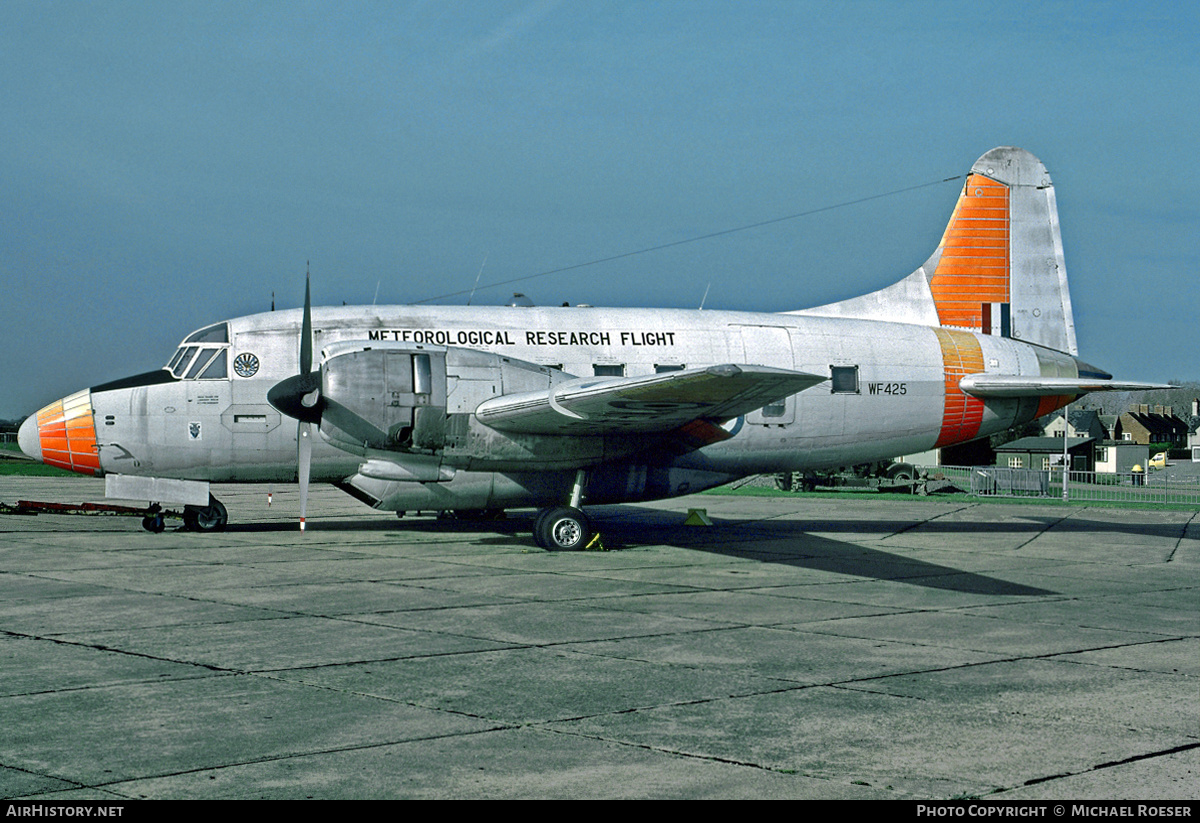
[794,146,1079,355]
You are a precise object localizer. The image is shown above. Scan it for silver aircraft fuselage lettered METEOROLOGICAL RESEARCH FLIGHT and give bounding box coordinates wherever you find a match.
[65,306,1076,507]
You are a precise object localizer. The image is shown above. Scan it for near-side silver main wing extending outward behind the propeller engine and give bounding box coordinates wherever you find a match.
[475,364,829,434]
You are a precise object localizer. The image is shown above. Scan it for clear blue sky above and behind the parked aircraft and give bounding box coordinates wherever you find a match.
[0,0,1200,417]
